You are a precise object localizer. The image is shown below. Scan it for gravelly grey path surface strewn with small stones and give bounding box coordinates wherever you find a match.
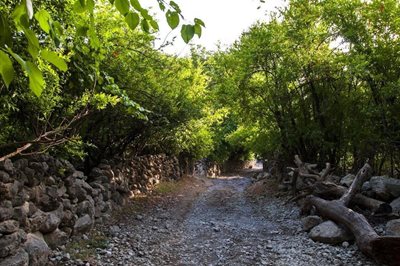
[52,171,375,266]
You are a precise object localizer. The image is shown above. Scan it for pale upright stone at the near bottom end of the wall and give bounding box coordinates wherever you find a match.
[24,232,51,266]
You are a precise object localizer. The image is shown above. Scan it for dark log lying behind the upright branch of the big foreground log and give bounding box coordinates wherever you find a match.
[312,182,392,214]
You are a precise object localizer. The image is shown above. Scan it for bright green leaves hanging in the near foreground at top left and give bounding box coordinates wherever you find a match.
[0,0,204,96]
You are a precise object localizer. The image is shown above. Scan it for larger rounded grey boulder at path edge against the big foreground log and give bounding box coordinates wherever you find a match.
[309,221,353,245]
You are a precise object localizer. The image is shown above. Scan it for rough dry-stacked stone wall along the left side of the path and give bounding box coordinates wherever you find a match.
[0,155,181,266]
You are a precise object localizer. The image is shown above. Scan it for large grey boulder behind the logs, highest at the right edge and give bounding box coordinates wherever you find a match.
[370,176,400,201]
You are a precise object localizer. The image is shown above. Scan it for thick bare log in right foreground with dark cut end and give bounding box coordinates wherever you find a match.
[307,196,400,265]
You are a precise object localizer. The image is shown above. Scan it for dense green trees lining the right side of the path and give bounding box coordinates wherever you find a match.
[206,0,400,171]
